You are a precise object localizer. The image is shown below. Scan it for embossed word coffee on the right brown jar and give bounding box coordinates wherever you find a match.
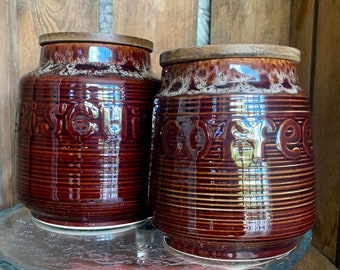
[162,116,313,162]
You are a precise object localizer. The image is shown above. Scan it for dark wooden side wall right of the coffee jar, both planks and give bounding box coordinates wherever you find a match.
[290,0,340,266]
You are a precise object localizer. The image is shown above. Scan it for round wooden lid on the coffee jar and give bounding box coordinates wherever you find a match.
[160,44,300,67]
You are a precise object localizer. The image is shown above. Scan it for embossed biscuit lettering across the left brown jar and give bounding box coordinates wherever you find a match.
[17,96,146,141]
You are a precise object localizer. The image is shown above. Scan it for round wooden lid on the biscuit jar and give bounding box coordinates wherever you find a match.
[39,32,153,52]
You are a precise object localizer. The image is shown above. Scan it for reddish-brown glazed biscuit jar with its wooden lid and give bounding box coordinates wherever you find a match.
[17,32,159,229]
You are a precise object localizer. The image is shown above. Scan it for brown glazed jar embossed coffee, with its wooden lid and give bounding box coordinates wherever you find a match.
[150,44,315,260]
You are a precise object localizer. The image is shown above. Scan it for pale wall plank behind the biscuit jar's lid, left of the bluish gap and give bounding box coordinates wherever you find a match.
[17,0,98,76]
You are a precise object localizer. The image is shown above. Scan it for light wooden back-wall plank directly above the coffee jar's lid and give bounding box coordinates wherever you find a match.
[211,0,291,45]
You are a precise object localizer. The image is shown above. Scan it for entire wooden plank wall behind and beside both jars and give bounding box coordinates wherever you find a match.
[0,0,340,262]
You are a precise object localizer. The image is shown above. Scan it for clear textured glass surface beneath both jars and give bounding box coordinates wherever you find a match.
[0,204,312,270]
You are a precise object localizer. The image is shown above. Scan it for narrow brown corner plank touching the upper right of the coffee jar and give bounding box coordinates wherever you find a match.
[289,0,315,98]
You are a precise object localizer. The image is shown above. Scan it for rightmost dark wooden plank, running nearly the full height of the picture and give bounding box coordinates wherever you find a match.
[313,0,340,262]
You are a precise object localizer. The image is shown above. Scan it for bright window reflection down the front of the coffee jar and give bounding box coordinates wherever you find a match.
[231,95,275,236]
